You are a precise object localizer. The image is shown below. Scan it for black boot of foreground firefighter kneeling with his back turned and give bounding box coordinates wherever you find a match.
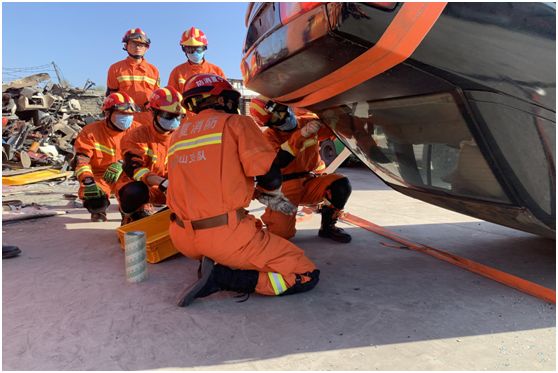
[177,257,259,307]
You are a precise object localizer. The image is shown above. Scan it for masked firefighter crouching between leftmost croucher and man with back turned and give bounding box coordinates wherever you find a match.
[117,87,186,225]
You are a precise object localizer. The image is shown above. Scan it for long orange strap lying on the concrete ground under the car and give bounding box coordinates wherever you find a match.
[340,213,556,304]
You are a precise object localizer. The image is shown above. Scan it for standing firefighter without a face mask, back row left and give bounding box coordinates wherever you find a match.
[107,28,160,125]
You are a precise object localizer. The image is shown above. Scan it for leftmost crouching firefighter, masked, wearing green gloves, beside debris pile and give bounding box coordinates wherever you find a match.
[73,93,139,221]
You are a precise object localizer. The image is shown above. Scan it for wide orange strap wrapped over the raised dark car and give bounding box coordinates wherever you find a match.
[275,3,447,107]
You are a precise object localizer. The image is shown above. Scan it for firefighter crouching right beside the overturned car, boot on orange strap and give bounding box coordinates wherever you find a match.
[250,96,351,243]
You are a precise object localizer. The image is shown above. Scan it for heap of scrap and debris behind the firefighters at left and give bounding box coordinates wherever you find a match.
[2,73,104,170]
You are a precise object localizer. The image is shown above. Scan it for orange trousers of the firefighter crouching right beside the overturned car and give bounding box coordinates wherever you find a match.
[262,174,345,239]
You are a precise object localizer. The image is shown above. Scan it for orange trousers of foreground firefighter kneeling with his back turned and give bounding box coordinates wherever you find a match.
[169,211,316,295]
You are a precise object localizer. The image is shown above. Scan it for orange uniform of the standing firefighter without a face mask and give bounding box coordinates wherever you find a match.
[107,57,160,124]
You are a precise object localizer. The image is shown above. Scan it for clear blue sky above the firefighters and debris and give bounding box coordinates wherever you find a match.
[2,2,248,87]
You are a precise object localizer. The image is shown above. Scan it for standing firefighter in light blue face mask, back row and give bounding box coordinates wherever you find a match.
[167,27,226,93]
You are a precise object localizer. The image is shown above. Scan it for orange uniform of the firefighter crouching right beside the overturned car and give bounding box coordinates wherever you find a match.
[262,115,344,239]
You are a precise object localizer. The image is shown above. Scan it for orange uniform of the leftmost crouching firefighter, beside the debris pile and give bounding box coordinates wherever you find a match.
[74,119,140,199]
